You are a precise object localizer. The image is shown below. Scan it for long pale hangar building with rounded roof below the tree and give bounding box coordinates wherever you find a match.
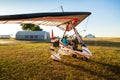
[15,31,50,41]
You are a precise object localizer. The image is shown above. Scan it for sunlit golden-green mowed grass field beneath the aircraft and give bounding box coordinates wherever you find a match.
[0,38,120,80]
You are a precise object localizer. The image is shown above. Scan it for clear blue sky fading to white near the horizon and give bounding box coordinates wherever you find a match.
[0,0,120,37]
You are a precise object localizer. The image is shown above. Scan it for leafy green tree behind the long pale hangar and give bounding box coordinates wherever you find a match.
[20,23,43,31]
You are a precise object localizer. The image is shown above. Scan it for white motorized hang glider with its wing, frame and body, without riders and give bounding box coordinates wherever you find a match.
[0,12,92,61]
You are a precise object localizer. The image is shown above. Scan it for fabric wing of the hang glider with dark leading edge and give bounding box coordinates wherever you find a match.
[0,12,91,31]
